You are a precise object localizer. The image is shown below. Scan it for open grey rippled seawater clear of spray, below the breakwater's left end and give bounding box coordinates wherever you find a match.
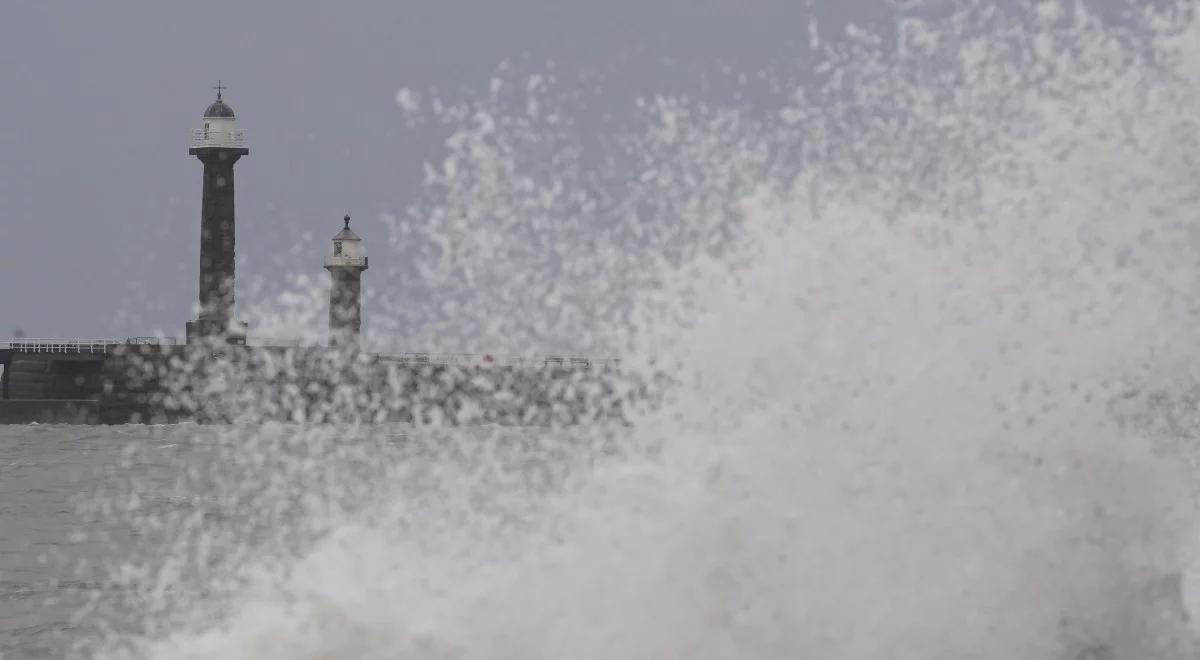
[0,425,192,660]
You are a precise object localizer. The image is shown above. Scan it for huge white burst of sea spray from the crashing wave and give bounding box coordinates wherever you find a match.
[87,2,1200,659]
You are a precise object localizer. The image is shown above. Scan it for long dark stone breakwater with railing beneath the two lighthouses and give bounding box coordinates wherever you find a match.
[0,343,637,426]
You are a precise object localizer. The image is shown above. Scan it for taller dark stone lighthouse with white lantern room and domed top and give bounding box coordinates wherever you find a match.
[187,83,250,343]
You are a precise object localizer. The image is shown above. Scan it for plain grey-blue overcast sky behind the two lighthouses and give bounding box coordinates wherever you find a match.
[0,0,1120,337]
